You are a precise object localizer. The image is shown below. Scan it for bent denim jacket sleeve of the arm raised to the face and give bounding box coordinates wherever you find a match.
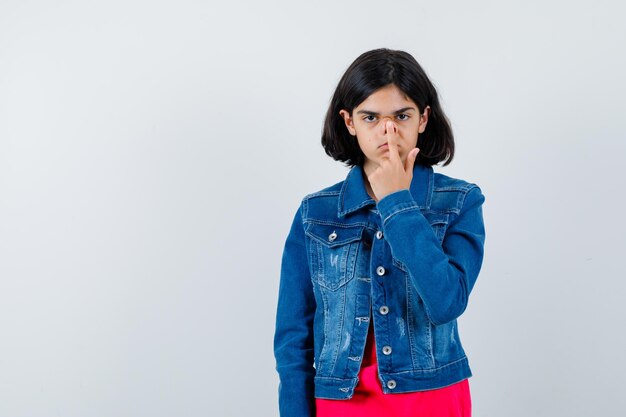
[377,184,485,325]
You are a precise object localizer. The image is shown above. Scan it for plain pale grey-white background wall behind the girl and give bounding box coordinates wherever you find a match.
[0,0,626,417]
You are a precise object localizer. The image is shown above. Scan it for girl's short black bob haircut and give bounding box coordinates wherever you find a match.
[322,48,454,167]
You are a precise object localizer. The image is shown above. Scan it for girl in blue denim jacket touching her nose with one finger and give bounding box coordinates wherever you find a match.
[274,49,485,417]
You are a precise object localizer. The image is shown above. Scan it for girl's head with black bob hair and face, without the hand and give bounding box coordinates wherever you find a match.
[322,48,454,166]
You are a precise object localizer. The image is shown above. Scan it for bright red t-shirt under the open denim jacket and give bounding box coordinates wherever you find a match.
[315,319,472,417]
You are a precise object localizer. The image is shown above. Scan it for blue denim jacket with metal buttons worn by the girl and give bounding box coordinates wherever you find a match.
[274,164,485,417]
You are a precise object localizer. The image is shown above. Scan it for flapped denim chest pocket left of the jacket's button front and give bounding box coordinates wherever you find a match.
[305,223,365,291]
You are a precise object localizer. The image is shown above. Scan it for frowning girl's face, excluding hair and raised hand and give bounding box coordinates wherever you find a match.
[339,84,430,175]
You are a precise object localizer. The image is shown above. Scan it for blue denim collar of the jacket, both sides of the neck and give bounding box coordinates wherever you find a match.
[337,163,433,217]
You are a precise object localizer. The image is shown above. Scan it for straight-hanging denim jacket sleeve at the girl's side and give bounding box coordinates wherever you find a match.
[274,203,315,417]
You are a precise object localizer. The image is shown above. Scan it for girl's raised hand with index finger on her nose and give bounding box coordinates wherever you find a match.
[367,120,419,201]
